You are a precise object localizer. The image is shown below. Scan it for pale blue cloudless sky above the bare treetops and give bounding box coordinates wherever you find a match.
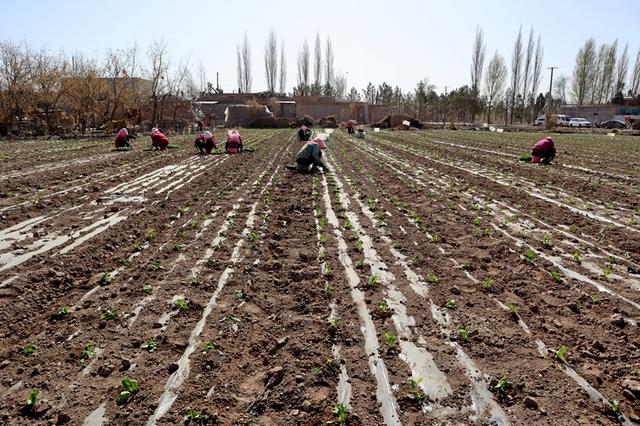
[0,0,640,95]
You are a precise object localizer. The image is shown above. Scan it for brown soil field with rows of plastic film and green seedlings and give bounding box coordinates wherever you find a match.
[0,130,640,425]
